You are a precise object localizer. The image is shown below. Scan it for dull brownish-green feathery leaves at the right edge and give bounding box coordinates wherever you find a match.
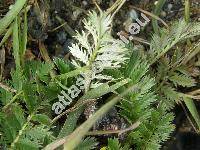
[148,20,200,128]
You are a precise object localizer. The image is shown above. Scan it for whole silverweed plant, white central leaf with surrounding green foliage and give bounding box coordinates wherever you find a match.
[0,0,200,150]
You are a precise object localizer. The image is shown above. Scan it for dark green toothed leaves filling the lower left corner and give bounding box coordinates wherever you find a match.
[0,62,57,149]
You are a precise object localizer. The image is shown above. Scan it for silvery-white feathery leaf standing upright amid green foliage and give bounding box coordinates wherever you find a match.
[70,11,128,89]
